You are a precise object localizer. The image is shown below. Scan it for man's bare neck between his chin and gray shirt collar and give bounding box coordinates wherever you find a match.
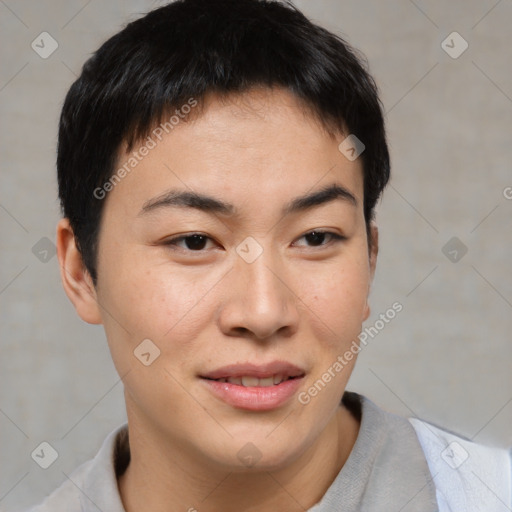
[118,405,359,512]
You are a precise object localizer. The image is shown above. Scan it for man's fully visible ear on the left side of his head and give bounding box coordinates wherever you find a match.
[57,218,102,324]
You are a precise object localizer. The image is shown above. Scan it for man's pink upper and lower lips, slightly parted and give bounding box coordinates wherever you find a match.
[200,361,305,411]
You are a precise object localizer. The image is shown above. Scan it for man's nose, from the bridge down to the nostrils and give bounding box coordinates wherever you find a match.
[218,250,300,341]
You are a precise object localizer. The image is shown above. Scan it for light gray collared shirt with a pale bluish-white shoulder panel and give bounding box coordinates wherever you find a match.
[22,392,512,512]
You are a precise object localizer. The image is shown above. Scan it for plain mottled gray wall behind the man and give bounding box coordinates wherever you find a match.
[0,0,512,511]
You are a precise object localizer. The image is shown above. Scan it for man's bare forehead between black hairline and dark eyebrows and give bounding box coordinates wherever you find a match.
[109,89,363,222]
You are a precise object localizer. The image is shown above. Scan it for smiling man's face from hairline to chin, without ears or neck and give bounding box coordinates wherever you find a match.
[63,90,375,468]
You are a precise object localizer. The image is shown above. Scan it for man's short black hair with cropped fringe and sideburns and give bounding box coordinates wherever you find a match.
[57,0,390,284]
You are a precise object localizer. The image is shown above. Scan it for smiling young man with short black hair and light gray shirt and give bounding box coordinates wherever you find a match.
[27,0,512,512]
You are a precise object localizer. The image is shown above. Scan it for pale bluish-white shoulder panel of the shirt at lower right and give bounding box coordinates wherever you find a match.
[409,418,512,512]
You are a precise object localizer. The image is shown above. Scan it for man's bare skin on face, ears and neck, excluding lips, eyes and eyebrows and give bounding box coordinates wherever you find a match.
[57,89,378,512]
